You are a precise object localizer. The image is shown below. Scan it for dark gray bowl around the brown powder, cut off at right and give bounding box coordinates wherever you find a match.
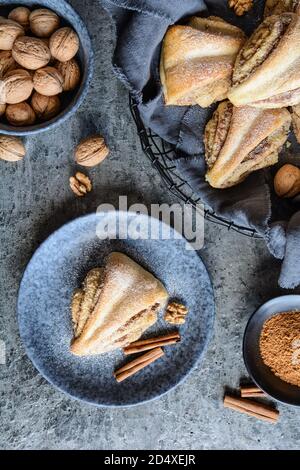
[243,295,300,406]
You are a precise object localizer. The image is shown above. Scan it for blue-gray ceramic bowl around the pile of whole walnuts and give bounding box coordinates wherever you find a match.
[0,0,93,136]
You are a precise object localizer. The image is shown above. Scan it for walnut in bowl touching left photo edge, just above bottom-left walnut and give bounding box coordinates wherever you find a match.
[0,69,33,104]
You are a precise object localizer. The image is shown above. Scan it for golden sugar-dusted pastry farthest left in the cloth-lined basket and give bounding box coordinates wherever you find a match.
[160,16,246,107]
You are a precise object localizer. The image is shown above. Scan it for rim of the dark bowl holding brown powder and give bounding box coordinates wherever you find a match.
[243,294,300,408]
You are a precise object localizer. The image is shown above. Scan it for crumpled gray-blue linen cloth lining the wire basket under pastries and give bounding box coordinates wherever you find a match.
[101,0,300,288]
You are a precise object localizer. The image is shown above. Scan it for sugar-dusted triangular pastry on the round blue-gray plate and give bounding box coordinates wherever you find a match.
[71,253,168,356]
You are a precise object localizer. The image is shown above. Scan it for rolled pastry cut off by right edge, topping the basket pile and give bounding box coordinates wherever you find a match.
[228,13,300,108]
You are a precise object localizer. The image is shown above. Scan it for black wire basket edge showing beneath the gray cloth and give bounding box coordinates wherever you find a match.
[129,96,262,238]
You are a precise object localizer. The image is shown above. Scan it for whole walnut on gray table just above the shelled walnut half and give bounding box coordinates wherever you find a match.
[75,135,109,167]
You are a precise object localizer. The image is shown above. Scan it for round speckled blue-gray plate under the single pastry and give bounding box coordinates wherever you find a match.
[18,212,214,406]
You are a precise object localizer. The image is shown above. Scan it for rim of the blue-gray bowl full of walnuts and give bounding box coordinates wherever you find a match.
[0,0,94,137]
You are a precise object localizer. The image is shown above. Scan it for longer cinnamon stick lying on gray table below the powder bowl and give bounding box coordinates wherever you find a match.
[224,395,279,423]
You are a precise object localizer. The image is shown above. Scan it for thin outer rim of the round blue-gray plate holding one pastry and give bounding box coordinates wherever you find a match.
[17,211,215,409]
